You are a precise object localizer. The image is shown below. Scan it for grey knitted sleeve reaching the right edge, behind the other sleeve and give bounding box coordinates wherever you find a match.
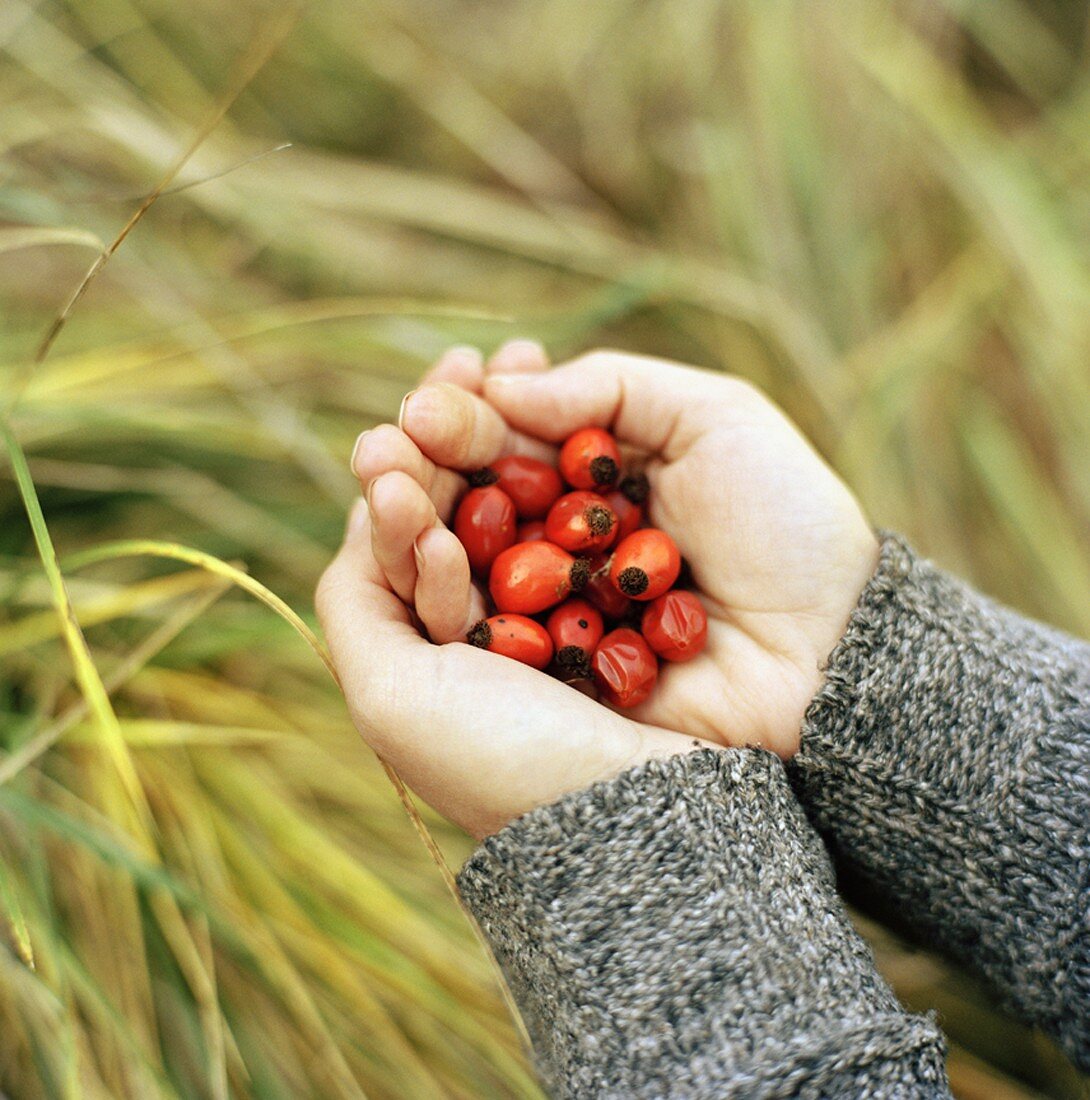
[789,536,1090,1069]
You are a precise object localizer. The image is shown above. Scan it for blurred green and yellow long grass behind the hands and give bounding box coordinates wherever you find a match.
[0,0,1090,1100]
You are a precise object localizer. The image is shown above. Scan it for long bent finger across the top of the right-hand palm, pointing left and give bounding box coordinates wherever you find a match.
[484,352,730,460]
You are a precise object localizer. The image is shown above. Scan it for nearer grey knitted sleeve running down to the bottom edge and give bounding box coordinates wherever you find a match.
[459,749,949,1100]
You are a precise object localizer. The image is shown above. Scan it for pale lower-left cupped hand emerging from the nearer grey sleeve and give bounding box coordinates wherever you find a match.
[316,344,725,838]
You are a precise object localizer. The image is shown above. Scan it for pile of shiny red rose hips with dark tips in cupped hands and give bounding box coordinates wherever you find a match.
[454,428,707,707]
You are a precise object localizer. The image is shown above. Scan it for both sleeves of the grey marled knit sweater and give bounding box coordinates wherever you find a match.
[459,536,1090,1100]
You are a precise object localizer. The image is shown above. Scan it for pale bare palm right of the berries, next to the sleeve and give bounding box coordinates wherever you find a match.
[620,391,874,755]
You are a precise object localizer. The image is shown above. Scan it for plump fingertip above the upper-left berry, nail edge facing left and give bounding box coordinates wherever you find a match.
[398,382,555,470]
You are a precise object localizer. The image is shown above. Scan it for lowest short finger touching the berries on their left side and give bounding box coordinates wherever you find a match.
[414,527,487,645]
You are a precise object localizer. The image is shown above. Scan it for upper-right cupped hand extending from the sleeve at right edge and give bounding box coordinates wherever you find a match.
[387,344,878,758]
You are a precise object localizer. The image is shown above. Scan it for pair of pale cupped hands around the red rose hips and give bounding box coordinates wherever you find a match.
[317,341,878,838]
